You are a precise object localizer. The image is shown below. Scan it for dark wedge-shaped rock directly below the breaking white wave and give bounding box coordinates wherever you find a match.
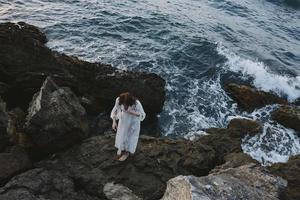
[225,83,287,112]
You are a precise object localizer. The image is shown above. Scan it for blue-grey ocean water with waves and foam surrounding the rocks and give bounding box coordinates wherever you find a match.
[0,0,300,164]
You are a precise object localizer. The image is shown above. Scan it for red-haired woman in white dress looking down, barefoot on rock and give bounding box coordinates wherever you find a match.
[110,92,146,161]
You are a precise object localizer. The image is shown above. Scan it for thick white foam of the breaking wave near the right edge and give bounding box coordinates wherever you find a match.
[217,44,300,101]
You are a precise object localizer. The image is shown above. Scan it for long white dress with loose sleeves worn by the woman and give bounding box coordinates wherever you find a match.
[110,97,146,154]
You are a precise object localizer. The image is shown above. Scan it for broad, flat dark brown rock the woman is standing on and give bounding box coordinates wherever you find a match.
[36,135,215,200]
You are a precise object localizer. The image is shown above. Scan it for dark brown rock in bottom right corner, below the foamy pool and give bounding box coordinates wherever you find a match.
[268,155,300,200]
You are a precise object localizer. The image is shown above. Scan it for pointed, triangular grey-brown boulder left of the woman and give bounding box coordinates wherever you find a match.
[25,77,88,154]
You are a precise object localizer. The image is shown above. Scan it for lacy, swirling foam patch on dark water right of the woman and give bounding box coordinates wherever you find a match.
[161,76,237,136]
